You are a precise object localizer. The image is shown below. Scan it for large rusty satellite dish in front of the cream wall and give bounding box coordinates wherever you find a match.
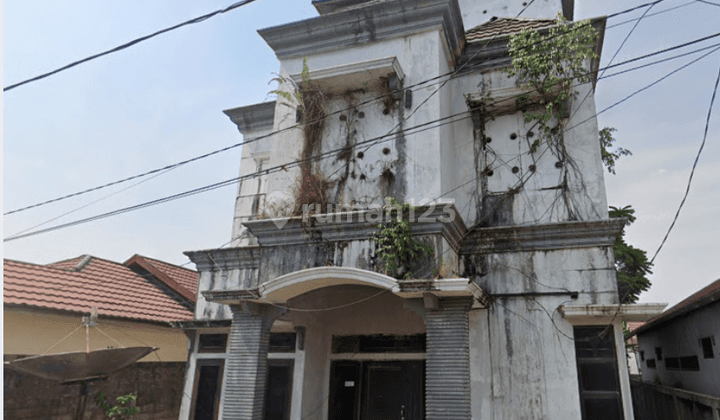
[5,347,157,383]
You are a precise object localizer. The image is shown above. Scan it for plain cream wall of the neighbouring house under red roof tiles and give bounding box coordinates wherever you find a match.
[3,308,187,362]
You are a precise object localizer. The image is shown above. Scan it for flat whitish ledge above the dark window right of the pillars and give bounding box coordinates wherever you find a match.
[558,303,667,324]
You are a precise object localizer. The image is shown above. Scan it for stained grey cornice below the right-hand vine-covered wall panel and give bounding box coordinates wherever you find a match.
[461,218,625,255]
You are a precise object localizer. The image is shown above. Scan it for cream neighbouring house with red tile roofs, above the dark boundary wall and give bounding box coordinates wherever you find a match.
[3,255,197,362]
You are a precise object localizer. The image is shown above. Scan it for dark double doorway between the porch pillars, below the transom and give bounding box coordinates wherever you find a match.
[328,361,425,420]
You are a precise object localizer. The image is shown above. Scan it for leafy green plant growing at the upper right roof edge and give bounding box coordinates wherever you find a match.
[505,14,597,143]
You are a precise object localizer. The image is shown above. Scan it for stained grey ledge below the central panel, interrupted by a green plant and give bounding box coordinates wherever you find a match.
[243,202,467,251]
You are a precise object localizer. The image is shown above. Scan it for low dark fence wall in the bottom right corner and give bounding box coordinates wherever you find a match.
[630,380,720,420]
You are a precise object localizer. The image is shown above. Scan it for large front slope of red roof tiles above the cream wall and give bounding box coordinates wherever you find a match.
[3,256,197,322]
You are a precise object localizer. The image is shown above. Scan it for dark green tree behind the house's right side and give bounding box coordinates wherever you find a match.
[610,206,652,303]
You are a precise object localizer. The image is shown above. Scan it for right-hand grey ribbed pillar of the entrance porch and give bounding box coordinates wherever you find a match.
[425,298,472,420]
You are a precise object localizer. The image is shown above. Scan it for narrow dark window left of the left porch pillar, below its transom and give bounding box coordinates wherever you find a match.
[190,359,224,420]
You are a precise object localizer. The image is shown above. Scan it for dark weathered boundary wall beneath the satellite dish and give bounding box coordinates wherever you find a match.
[4,362,185,420]
